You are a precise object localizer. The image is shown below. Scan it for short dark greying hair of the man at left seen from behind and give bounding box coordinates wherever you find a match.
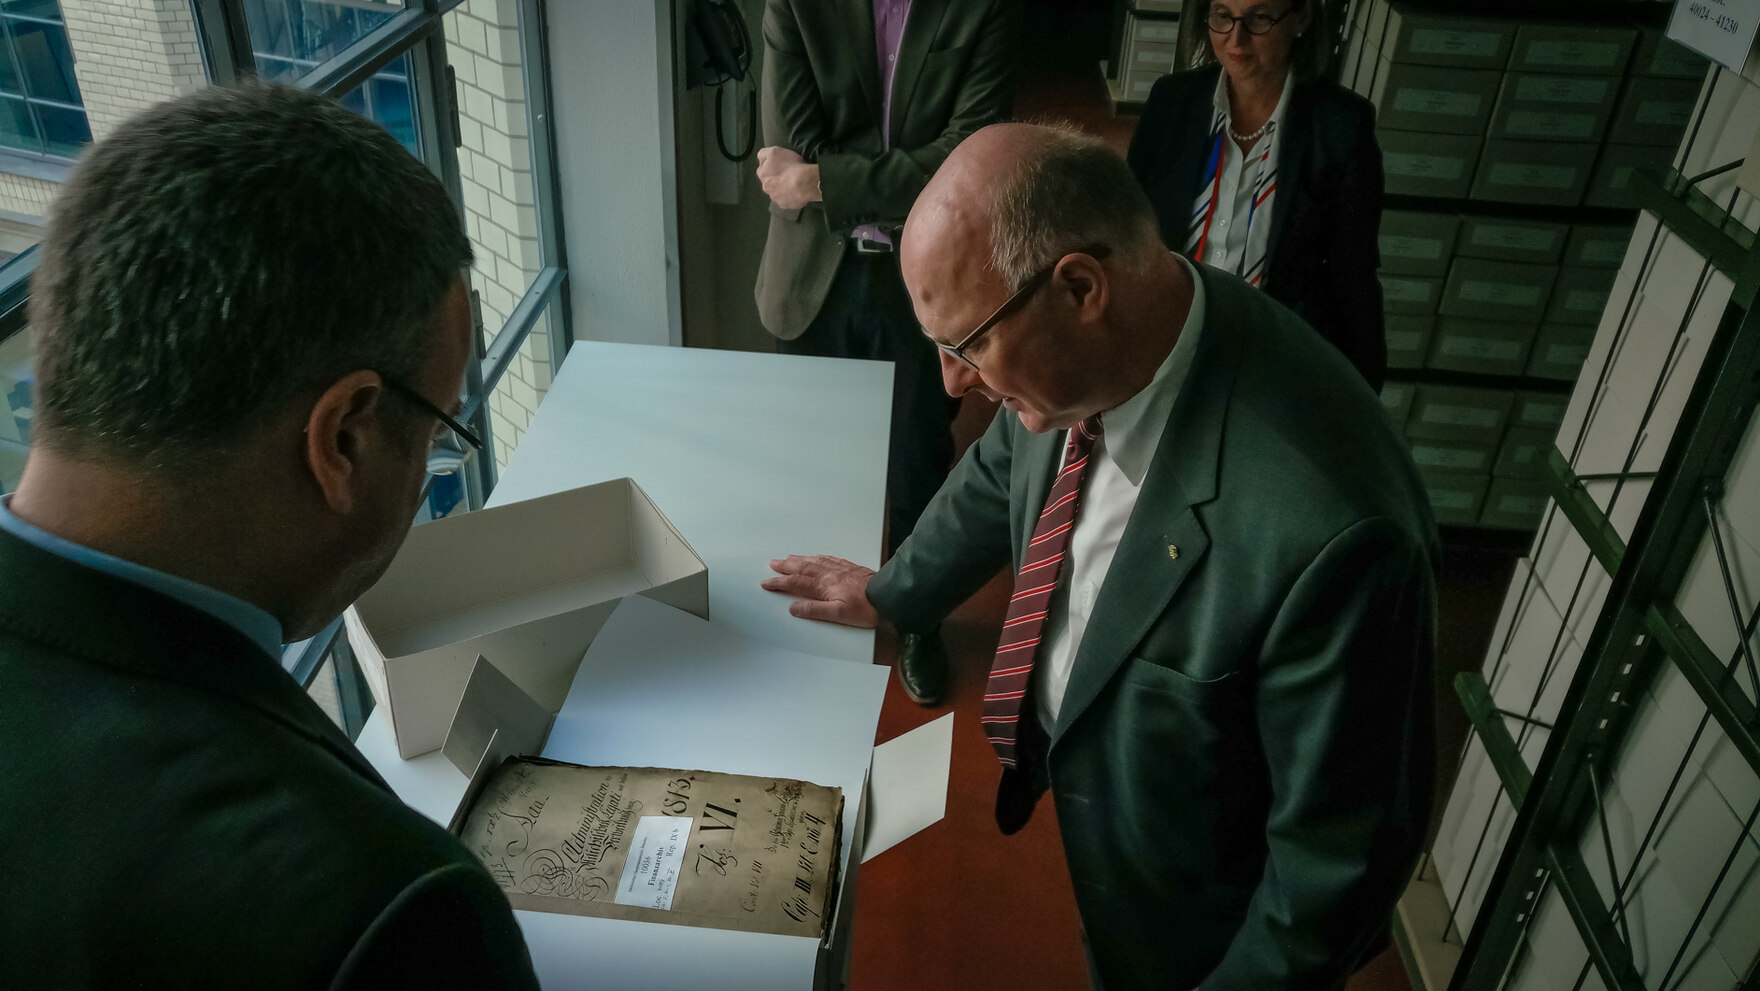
[30,84,472,463]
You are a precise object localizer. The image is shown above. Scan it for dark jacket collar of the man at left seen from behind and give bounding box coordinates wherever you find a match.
[0,532,385,787]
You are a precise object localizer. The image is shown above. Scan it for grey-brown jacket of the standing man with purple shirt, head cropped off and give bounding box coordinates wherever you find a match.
[753,0,1017,340]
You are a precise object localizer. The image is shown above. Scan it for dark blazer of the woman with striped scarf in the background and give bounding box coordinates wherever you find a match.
[1130,65,1387,391]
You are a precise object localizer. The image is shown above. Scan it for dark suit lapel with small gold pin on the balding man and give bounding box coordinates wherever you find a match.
[1051,266,1251,746]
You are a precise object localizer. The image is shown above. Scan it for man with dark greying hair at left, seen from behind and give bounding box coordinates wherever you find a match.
[0,86,537,987]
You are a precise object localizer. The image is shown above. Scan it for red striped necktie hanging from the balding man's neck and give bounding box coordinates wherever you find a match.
[984,415,1100,767]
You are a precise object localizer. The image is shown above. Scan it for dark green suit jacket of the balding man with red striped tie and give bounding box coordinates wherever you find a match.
[868,266,1438,991]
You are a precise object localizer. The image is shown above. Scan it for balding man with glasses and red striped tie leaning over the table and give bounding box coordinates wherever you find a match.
[766,125,1438,991]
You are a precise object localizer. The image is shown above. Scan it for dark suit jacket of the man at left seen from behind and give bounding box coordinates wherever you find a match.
[0,532,537,989]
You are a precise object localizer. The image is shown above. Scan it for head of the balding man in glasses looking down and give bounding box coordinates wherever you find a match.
[899,123,1190,431]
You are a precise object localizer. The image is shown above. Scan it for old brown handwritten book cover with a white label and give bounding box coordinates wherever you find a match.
[459,757,843,938]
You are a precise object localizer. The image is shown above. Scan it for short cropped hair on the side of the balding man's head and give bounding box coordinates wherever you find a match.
[991,123,1167,290]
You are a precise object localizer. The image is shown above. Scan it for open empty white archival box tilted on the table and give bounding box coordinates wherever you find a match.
[347,479,709,759]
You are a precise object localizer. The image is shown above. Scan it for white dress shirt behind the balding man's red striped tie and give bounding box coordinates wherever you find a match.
[1033,253,1204,732]
